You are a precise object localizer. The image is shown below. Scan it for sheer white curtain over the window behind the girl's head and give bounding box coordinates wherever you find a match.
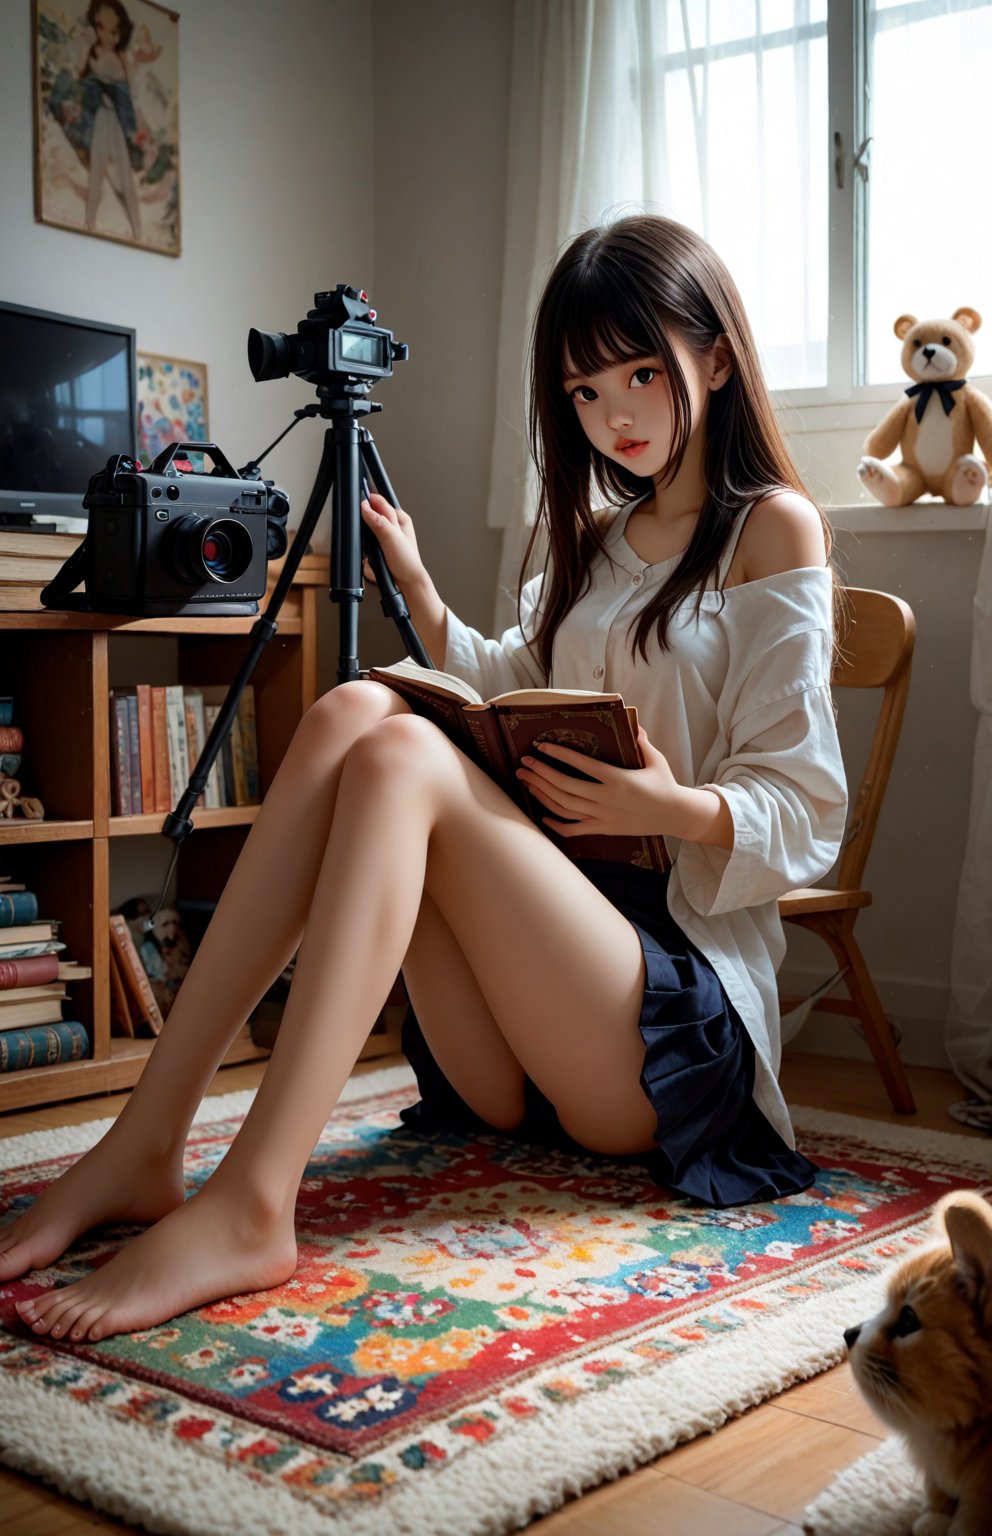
[488,0,828,631]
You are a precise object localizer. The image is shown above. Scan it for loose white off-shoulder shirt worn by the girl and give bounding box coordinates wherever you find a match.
[444,501,848,1146]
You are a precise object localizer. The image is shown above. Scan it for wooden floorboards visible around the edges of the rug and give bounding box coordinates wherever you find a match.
[0,1054,981,1536]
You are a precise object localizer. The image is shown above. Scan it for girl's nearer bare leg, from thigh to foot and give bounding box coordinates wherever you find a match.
[20,716,654,1339]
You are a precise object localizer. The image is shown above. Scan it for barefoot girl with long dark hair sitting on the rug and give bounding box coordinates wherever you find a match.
[0,218,846,1339]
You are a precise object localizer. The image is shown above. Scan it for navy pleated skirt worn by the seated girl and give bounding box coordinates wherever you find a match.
[401,860,817,1207]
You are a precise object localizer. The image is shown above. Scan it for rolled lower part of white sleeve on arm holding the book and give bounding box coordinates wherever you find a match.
[679,684,848,917]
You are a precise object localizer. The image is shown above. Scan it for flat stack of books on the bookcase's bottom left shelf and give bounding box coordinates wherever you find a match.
[0,876,92,1072]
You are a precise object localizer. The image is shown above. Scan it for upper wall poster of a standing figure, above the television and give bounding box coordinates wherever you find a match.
[32,0,180,257]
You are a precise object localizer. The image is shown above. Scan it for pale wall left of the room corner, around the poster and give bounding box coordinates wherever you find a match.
[0,0,373,559]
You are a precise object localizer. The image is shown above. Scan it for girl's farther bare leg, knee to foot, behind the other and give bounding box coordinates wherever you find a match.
[0,682,407,1281]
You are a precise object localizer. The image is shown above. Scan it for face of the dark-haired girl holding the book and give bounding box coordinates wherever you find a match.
[565,338,711,479]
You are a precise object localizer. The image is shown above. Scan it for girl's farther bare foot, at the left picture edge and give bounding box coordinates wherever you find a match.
[0,1129,184,1283]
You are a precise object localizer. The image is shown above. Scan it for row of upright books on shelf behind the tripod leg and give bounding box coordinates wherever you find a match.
[111,684,261,816]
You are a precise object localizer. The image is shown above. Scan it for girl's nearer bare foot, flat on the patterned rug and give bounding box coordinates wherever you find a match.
[17,1180,296,1342]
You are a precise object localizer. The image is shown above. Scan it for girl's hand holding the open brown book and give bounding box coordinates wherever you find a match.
[517,727,686,837]
